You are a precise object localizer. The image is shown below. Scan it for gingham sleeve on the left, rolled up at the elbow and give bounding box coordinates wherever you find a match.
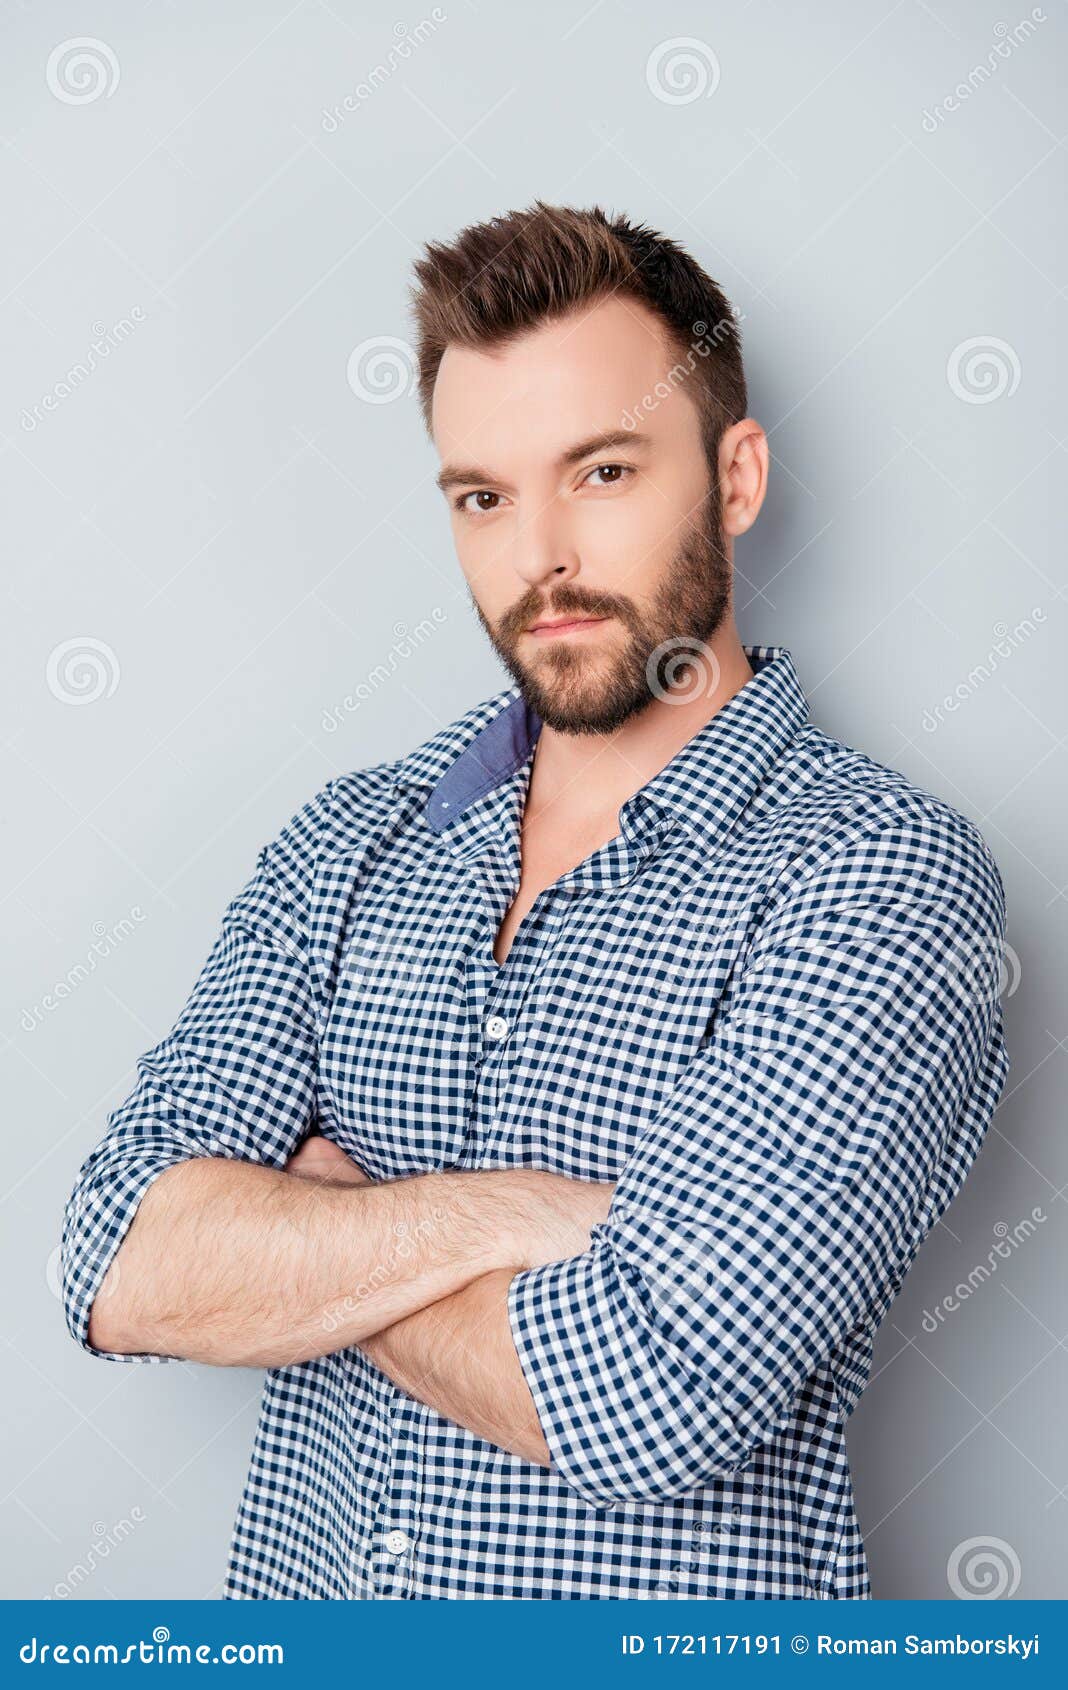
[61,788,330,1362]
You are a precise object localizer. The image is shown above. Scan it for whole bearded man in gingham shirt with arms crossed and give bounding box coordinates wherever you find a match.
[64,201,1007,1599]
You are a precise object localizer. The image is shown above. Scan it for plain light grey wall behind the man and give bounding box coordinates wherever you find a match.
[0,0,1068,1599]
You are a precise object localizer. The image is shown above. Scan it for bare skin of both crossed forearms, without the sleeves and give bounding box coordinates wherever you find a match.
[88,1136,613,1465]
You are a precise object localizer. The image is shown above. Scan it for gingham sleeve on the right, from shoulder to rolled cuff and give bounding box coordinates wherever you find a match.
[507,806,1007,1507]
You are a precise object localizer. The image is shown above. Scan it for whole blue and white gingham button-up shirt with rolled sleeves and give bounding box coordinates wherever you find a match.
[64,647,1007,1599]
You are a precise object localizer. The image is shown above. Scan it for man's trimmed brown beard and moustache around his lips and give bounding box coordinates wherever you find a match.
[468,487,732,733]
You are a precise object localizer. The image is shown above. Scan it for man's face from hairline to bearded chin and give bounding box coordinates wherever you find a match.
[433,297,730,733]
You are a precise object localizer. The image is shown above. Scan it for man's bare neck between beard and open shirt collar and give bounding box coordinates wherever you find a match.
[527,622,754,816]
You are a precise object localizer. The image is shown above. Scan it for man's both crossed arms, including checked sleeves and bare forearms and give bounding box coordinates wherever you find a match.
[64,813,1007,1507]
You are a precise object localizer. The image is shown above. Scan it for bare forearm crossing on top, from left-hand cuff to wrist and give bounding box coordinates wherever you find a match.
[90,1158,530,1367]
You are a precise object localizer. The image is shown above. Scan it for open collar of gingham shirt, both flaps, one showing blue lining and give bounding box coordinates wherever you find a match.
[394,646,808,837]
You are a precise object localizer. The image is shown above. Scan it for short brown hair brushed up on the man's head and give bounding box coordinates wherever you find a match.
[403,199,747,478]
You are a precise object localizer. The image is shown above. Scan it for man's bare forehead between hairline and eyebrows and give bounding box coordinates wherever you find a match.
[433,294,689,460]
